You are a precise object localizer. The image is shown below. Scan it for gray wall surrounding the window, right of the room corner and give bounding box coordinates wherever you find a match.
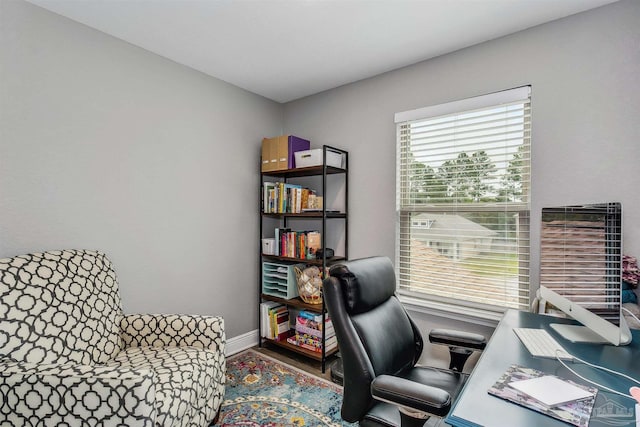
[284,0,640,320]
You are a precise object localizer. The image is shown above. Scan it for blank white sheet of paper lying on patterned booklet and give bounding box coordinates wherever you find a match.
[509,375,593,408]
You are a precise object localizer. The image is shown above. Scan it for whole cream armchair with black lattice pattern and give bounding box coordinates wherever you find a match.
[0,250,226,427]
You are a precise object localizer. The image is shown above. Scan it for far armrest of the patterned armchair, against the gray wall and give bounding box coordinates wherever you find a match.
[120,314,226,354]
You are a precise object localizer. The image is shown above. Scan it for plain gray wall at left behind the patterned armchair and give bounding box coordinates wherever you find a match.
[0,0,282,337]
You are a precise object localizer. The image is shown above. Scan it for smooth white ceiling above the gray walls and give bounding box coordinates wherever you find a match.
[27,0,615,102]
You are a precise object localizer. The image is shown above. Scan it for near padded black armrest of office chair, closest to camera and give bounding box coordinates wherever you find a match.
[371,375,451,417]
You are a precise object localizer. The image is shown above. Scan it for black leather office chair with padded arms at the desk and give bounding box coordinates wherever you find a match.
[323,257,486,427]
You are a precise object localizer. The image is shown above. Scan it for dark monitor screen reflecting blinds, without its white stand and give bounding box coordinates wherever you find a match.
[540,203,622,323]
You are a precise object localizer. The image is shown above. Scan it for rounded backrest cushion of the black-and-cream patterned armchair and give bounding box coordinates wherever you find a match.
[0,250,122,364]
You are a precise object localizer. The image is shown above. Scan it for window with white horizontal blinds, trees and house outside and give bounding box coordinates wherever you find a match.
[396,86,531,311]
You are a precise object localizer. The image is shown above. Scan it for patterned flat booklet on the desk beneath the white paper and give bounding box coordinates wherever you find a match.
[487,365,598,427]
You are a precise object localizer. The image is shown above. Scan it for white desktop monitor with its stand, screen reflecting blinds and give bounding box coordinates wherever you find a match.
[539,202,631,345]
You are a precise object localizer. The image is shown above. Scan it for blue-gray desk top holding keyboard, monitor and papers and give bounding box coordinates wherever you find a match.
[445,310,640,427]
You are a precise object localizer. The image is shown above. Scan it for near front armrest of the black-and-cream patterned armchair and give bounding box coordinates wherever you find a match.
[0,360,156,427]
